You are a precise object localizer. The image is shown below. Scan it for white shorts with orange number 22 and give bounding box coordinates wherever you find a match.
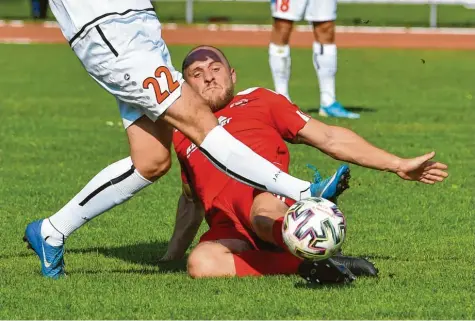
[73,12,184,128]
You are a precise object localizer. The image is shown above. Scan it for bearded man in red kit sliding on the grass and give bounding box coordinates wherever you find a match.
[162,46,447,281]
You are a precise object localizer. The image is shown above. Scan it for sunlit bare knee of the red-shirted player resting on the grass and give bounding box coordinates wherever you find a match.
[187,246,222,279]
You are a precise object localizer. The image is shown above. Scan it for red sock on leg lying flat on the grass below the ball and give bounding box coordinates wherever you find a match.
[233,250,302,276]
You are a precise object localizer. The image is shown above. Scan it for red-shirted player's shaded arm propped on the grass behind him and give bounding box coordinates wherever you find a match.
[160,183,204,261]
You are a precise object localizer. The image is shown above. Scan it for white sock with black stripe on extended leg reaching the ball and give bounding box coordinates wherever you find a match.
[200,126,310,200]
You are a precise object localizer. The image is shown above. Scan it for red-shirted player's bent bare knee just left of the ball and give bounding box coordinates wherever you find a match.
[251,192,293,243]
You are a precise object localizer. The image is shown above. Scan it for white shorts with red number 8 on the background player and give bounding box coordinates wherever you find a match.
[271,0,337,22]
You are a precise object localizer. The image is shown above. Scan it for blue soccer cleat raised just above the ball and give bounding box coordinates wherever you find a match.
[307,165,351,203]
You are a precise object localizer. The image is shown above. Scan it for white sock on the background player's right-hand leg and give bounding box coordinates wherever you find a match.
[313,42,337,106]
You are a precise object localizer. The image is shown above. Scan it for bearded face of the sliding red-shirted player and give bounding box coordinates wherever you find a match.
[186,58,236,111]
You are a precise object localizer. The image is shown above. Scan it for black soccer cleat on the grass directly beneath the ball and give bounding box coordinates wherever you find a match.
[298,258,356,284]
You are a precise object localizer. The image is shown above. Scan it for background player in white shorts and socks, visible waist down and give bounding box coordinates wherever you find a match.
[269,0,360,118]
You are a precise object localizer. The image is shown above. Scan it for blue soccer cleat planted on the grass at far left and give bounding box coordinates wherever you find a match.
[23,220,64,279]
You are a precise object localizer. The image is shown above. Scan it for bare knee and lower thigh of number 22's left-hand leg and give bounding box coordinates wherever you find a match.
[127,116,173,181]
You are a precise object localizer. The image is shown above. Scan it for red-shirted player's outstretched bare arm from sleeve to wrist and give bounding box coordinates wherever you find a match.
[298,119,401,172]
